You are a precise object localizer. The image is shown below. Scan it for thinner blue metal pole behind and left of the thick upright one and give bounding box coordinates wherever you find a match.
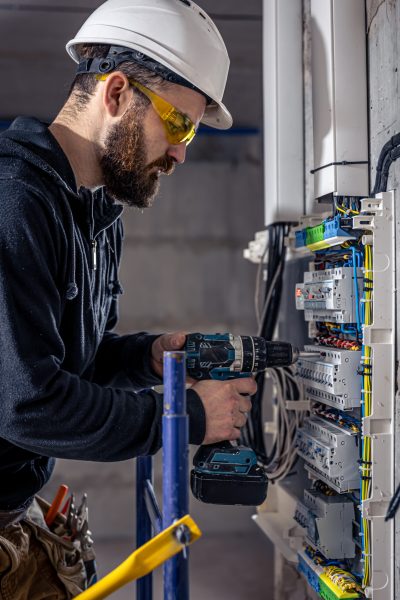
[136,456,153,600]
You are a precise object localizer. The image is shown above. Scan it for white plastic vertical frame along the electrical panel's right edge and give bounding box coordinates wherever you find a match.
[354,192,396,600]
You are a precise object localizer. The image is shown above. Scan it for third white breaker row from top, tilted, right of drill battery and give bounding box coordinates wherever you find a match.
[296,417,359,492]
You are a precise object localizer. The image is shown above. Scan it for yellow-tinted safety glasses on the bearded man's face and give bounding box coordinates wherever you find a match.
[96,75,196,145]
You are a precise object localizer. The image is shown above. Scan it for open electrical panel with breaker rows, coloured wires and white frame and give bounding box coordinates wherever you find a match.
[252,192,396,600]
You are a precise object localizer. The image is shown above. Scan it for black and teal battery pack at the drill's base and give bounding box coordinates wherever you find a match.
[190,442,268,506]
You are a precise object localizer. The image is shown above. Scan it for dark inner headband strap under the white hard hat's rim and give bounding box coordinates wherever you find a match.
[76,46,212,105]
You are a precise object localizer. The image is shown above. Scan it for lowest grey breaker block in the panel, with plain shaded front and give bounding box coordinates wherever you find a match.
[294,490,356,559]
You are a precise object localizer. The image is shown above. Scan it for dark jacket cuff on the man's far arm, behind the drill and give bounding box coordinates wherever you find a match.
[124,333,162,387]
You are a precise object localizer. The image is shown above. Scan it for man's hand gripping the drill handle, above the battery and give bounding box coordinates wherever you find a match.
[192,377,257,444]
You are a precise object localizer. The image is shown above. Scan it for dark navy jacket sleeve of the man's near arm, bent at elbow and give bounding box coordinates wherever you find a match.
[0,181,205,461]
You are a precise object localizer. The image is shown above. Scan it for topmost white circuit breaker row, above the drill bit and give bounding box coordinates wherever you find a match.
[296,267,363,323]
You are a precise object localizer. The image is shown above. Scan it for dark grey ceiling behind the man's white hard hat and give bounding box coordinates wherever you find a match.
[0,0,262,127]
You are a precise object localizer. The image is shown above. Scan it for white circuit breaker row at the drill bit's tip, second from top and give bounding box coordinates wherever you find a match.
[296,345,362,410]
